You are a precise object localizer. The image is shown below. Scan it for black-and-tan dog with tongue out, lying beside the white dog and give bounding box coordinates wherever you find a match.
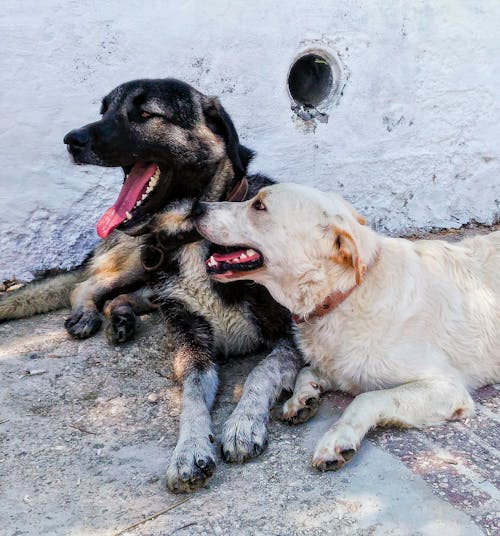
[0,79,302,492]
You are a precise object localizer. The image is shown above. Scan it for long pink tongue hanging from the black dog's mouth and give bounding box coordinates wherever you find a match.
[96,163,158,238]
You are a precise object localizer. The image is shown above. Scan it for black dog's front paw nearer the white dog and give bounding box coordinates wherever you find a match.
[221,411,267,463]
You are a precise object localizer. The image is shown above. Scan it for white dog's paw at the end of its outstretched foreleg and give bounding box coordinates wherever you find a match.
[312,425,360,471]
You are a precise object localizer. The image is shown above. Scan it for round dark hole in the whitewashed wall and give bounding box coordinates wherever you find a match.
[288,52,334,106]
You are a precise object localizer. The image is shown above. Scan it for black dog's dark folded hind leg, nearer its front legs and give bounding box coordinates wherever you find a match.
[103,288,158,344]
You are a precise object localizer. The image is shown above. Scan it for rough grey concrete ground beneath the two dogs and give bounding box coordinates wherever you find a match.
[0,311,500,536]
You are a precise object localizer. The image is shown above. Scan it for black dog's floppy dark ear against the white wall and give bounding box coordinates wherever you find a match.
[203,97,247,179]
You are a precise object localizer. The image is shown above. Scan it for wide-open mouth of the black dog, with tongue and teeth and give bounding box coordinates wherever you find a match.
[96,162,161,238]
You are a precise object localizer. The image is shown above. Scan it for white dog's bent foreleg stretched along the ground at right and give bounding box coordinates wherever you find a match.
[312,379,474,471]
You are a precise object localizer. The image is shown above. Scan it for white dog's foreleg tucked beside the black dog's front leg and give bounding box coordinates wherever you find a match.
[281,367,332,424]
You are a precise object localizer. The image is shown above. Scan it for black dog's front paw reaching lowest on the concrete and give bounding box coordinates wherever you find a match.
[167,437,215,493]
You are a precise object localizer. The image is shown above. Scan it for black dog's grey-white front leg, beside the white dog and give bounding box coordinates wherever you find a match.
[221,340,303,463]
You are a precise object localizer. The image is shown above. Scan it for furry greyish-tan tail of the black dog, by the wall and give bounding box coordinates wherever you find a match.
[0,267,85,323]
